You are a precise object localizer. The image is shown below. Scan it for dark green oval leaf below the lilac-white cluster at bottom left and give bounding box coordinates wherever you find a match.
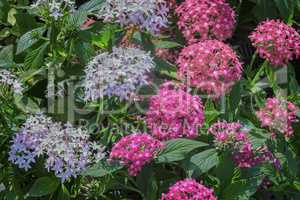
[28,176,59,197]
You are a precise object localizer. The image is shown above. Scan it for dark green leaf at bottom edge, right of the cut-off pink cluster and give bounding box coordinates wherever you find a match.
[221,176,263,200]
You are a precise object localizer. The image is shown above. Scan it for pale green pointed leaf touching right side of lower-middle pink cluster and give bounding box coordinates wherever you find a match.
[157,139,207,163]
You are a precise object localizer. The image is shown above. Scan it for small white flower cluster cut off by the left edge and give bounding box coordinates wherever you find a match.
[0,69,23,94]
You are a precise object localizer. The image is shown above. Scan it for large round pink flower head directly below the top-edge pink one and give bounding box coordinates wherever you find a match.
[177,40,242,98]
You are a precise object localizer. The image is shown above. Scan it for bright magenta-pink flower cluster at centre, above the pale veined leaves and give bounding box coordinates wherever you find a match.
[146,82,204,140]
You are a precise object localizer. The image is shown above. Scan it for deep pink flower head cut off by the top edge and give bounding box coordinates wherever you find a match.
[176,0,235,44]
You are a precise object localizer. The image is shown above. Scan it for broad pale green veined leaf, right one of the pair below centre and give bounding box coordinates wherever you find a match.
[191,149,219,173]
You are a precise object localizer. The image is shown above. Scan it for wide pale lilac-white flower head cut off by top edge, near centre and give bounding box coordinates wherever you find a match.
[98,0,169,34]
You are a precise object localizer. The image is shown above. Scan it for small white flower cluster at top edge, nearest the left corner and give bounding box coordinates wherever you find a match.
[32,0,75,20]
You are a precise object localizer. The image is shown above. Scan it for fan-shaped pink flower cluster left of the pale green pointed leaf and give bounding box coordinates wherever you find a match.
[109,133,164,176]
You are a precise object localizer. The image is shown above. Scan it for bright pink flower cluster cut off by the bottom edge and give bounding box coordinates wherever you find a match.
[161,179,217,200]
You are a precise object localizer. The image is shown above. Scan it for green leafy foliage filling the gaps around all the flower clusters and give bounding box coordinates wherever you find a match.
[0,0,300,200]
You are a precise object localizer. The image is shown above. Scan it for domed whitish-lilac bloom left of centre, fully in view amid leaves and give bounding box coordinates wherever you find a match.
[84,48,155,101]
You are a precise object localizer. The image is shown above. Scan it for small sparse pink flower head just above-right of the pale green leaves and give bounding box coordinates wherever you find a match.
[208,121,248,148]
